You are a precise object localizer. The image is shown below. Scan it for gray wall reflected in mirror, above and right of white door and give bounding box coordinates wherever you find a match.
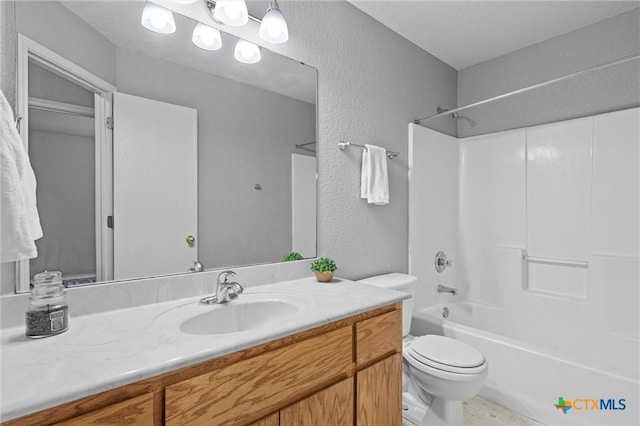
[117,49,316,268]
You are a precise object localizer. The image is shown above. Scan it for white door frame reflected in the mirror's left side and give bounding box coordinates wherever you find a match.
[16,33,116,293]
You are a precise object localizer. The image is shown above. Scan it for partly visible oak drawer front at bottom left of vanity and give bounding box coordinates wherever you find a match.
[56,393,153,426]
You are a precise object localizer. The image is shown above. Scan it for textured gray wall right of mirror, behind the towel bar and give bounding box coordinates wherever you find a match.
[168,1,457,279]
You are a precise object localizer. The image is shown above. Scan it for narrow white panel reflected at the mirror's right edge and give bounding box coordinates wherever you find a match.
[291,154,316,258]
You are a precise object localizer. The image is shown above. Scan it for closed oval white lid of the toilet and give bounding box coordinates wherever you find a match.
[408,334,486,373]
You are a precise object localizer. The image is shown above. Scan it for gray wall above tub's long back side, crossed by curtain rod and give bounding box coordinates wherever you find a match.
[458,9,640,137]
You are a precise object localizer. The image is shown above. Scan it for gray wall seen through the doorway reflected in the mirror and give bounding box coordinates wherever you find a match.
[29,126,96,276]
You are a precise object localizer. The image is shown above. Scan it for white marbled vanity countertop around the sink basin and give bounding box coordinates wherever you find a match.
[0,278,408,421]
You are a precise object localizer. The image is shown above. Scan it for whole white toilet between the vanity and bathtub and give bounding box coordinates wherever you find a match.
[359,273,489,426]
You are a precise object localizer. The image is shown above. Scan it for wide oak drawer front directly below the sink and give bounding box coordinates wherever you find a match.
[165,327,352,426]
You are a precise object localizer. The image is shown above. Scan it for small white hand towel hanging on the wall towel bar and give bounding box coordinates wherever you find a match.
[360,145,389,206]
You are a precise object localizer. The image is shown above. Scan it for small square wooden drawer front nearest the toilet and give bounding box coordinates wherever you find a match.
[356,309,402,365]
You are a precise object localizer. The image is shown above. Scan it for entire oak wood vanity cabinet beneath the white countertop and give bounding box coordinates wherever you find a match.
[3,303,402,426]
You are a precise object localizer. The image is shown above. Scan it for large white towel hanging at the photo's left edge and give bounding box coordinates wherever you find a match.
[0,90,42,262]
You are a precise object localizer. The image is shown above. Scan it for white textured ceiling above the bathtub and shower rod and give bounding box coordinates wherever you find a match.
[348,0,640,70]
